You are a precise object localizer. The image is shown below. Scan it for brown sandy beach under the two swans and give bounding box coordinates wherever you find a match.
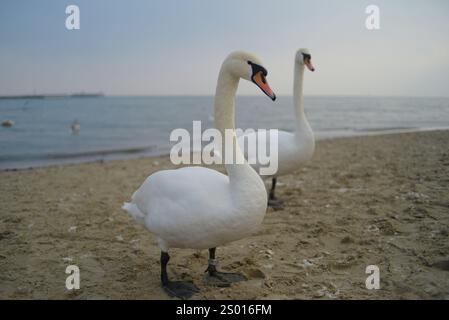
[0,131,449,299]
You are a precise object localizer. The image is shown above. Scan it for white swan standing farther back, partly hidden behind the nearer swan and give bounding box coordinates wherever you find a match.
[238,49,315,208]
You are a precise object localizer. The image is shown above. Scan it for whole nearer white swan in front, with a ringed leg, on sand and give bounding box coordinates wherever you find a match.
[123,52,276,298]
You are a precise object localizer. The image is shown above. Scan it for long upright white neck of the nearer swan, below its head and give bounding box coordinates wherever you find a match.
[214,68,245,174]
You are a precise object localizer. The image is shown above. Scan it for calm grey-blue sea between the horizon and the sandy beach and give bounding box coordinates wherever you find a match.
[0,96,449,169]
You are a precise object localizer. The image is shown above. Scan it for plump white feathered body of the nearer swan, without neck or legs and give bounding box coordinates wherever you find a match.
[123,167,266,251]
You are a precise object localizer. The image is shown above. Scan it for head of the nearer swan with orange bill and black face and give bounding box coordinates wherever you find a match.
[223,51,276,101]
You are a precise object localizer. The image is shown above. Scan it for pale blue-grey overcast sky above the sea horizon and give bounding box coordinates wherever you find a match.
[0,0,449,96]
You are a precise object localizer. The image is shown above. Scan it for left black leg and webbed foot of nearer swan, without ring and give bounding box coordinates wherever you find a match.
[161,251,200,299]
